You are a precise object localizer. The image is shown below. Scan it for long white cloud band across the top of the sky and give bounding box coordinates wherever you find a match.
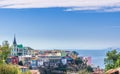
[0,0,120,12]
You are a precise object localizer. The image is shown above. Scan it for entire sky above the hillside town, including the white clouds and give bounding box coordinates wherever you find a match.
[0,0,120,49]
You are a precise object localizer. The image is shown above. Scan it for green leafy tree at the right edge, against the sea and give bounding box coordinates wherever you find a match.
[104,50,120,71]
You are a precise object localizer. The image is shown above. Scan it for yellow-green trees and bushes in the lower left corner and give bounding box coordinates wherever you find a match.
[0,41,31,74]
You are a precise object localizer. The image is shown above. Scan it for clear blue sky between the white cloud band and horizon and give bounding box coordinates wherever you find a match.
[0,7,120,49]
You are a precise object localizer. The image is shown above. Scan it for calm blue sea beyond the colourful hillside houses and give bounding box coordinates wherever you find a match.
[76,49,120,69]
